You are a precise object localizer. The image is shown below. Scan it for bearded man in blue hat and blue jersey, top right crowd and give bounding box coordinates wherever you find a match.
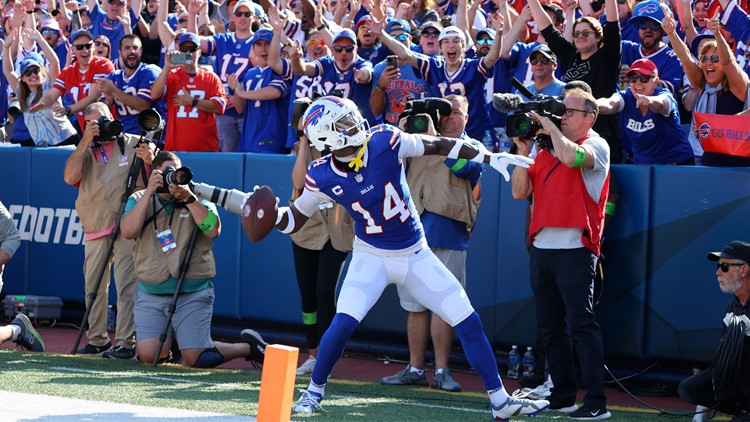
[621,0,685,95]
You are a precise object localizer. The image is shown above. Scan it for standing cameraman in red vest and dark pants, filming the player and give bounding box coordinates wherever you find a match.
[512,89,611,419]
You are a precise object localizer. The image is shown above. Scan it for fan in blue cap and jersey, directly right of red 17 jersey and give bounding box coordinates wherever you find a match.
[229,29,289,154]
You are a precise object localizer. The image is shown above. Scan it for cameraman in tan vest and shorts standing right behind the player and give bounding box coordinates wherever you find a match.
[380,95,482,391]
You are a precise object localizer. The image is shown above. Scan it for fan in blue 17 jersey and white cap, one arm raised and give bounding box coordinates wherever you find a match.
[188,0,257,152]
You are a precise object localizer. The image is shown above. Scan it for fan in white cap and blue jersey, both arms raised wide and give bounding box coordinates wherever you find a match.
[371,12,503,139]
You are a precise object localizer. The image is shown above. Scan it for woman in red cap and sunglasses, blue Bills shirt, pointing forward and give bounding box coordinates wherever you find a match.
[596,59,695,165]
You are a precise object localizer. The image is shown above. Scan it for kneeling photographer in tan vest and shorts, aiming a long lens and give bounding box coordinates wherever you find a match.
[120,151,265,368]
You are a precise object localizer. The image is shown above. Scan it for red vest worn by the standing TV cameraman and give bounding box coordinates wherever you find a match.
[529,136,609,256]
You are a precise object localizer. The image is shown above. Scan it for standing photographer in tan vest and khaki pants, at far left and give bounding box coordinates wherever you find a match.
[64,102,153,359]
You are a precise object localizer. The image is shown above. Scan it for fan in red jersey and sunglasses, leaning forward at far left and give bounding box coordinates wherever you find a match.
[29,29,115,128]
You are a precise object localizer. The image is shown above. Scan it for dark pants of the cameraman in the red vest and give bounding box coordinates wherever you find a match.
[530,246,607,407]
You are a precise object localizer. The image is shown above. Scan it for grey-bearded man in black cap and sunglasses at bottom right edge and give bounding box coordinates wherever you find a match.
[677,240,750,422]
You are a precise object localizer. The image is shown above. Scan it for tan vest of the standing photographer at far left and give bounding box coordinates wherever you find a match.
[76,135,145,233]
